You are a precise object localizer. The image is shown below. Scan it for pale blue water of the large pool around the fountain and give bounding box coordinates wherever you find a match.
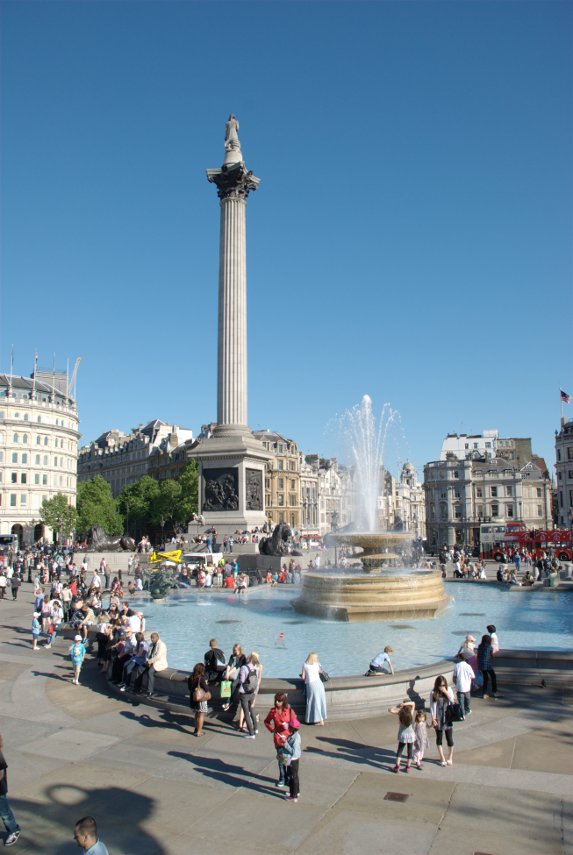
[126,583,573,678]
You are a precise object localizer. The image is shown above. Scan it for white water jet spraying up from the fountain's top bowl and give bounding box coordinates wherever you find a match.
[340,395,397,532]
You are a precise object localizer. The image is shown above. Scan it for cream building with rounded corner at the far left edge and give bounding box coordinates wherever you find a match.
[0,369,79,545]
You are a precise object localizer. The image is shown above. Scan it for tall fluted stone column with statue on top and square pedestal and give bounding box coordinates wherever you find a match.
[193,115,271,534]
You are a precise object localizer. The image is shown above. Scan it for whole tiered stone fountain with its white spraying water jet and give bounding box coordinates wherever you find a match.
[294,395,449,621]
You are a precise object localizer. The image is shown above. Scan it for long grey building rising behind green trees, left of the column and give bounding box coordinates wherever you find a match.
[78,419,193,496]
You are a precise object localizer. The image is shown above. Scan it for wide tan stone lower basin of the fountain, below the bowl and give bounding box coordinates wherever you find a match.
[293,568,450,622]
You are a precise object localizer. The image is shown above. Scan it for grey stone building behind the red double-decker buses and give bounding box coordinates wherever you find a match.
[424,452,552,549]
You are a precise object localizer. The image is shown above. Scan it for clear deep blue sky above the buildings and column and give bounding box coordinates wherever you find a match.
[0,0,573,468]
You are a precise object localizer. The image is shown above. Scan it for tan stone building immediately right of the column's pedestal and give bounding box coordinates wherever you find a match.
[254,430,302,531]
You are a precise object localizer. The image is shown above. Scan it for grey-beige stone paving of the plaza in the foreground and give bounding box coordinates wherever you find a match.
[0,584,573,855]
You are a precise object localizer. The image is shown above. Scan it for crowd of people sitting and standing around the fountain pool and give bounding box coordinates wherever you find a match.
[0,536,512,855]
